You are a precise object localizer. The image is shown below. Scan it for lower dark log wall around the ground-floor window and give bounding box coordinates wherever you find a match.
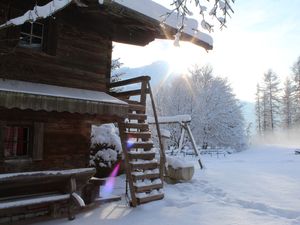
[0,109,91,173]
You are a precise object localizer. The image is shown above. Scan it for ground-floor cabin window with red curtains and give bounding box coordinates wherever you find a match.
[3,126,32,159]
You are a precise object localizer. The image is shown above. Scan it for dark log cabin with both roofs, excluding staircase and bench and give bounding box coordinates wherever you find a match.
[0,0,212,173]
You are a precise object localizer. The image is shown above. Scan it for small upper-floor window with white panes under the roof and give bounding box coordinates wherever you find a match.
[19,22,44,49]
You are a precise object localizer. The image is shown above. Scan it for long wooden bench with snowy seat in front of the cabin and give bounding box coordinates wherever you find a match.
[0,168,95,224]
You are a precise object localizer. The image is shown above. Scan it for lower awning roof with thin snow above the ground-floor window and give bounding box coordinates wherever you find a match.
[0,79,128,118]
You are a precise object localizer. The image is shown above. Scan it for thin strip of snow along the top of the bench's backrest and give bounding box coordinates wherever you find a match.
[0,168,94,181]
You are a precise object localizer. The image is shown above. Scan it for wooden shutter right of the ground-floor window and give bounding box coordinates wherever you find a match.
[32,122,44,161]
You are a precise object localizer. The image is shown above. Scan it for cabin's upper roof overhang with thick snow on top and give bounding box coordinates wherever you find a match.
[0,0,213,50]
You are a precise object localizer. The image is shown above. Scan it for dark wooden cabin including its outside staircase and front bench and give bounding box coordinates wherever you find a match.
[0,0,212,221]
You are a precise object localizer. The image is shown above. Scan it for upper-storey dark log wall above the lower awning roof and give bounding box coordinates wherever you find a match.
[0,3,112,91]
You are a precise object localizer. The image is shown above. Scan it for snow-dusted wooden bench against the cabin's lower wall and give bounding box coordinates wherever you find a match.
[0,168,95,219]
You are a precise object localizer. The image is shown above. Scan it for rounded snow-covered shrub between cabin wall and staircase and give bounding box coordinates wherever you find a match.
[90,124,122,176]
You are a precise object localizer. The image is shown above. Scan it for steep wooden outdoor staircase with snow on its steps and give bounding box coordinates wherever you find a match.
[111,76,165,207]
